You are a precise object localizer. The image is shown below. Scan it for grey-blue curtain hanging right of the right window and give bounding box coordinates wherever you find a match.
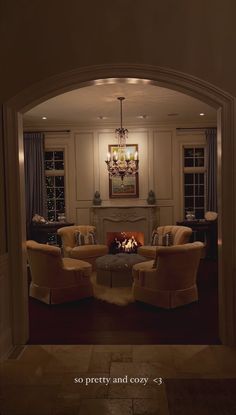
[206,128,217,212]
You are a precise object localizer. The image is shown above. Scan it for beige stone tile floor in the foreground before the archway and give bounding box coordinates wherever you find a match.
[0,345,236,415]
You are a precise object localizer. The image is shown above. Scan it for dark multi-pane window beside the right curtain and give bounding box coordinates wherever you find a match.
[184,146,206,219]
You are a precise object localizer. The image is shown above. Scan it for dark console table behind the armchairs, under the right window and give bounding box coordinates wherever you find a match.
[176,219,217,259]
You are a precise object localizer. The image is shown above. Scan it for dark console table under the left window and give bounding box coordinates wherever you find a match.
[30,222,74,247]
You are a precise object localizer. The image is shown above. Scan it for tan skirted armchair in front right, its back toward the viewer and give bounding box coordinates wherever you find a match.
[132,242,204,308]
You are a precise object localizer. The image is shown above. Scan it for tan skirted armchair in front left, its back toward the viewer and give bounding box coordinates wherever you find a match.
[26,241,93,304]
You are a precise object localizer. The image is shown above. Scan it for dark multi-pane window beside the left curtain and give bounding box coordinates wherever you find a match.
[44,150,65,221]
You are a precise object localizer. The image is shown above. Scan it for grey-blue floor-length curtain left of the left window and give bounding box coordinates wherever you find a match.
[24,132,46,238]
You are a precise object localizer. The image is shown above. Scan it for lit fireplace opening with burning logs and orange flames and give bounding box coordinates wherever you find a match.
[107,232,144,254]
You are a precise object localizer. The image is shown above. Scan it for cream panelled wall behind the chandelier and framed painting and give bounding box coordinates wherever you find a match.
[45,126,205,231]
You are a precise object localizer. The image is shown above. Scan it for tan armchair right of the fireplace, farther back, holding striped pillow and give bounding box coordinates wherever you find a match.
[138,225,192,259]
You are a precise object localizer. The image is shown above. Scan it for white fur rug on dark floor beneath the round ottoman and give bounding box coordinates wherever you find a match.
[91,272,134,306]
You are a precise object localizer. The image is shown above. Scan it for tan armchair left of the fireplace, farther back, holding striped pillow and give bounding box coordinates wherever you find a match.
[57,225,108,269]
